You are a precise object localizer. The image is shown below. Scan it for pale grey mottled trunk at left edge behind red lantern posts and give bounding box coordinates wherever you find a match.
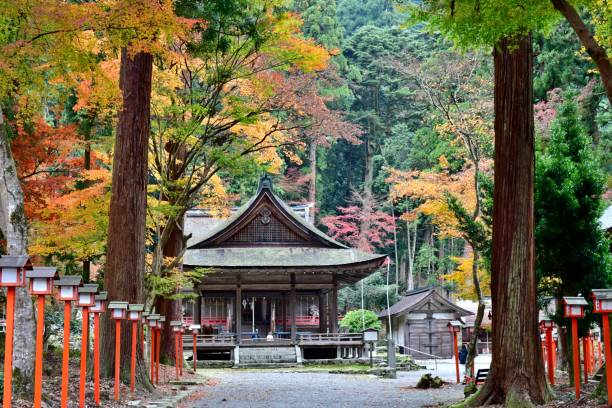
[0,107,35,396]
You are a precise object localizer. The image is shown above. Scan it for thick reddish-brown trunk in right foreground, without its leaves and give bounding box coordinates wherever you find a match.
[475,35,550,407]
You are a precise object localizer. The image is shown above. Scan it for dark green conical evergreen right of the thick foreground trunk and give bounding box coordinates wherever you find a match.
[535,94,612,332]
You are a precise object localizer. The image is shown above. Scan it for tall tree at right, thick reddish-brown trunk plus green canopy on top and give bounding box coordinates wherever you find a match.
[411,0,550,406]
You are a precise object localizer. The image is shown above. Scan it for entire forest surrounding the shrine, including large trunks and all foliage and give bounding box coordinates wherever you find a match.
[0,0,612,401]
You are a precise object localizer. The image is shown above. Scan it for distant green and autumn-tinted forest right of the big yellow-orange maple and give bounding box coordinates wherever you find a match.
[228,0,612,310]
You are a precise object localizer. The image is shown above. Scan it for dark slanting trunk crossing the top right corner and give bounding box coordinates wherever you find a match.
[551,0,612,103]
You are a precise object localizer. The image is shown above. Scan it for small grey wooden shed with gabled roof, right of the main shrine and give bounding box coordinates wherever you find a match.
[379,288,473,358]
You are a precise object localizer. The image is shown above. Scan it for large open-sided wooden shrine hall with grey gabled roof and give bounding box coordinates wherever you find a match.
[183,176,385,360]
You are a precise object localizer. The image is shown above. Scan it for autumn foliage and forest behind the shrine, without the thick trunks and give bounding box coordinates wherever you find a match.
[0,0,612,390]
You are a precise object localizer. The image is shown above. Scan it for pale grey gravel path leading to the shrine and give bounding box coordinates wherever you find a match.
[190,369,463,408]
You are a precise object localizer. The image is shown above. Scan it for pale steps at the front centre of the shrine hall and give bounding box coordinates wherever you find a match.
[234,346,302,367]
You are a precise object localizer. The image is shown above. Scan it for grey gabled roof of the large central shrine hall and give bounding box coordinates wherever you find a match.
[183,177,386,282]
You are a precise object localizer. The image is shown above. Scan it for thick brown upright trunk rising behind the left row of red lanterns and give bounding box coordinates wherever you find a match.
[100,48,153,387]
